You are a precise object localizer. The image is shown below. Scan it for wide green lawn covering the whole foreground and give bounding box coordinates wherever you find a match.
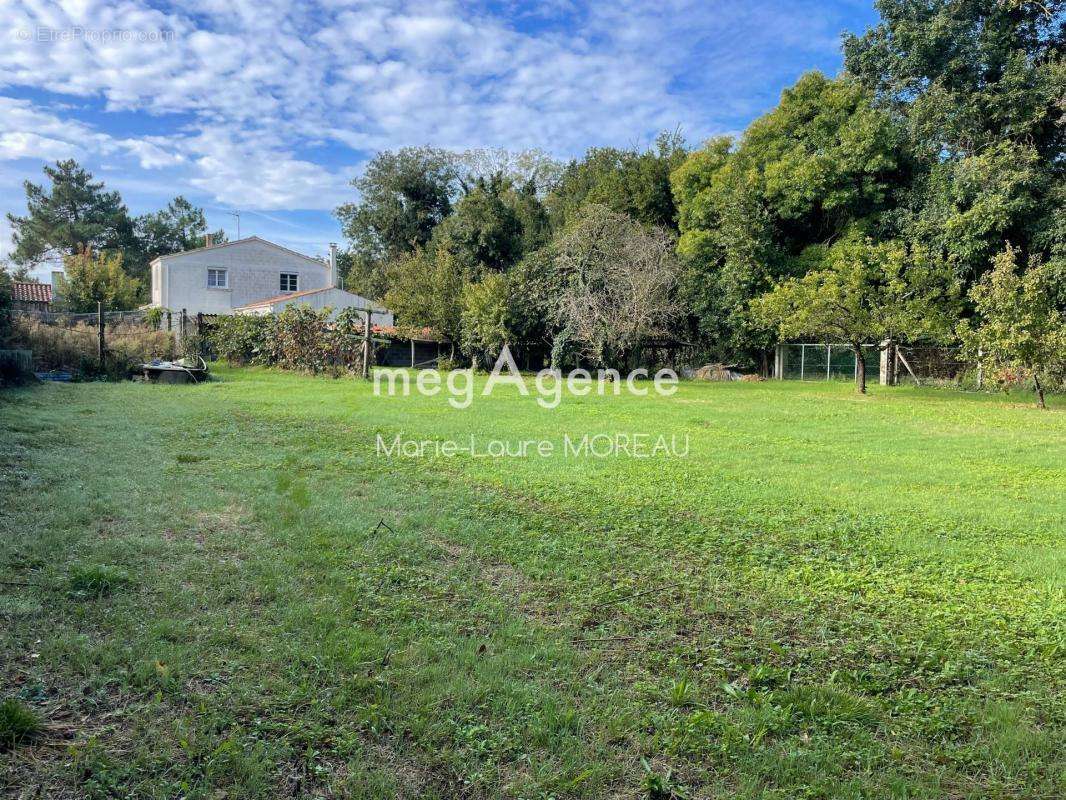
[0,369,1066,799]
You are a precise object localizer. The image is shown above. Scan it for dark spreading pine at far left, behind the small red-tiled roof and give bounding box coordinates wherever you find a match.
[7,159,133,266]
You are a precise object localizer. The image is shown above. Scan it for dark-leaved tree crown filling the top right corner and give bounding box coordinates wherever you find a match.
[844,0,1066,159]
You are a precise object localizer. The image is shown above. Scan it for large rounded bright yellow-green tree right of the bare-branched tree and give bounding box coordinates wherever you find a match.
[672,73,911,369]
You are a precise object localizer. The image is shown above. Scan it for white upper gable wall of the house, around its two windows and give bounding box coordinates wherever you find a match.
[151,237,330,315]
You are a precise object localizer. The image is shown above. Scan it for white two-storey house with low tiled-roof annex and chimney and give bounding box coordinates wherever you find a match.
[149,236,393,325]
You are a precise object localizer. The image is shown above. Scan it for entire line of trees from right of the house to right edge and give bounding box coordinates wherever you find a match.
[336,0,1066,401]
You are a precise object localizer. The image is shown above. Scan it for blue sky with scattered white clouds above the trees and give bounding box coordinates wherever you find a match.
[0,0,876,279]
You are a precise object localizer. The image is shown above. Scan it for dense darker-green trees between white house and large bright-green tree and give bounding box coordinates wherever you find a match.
[337,141,685,373]
